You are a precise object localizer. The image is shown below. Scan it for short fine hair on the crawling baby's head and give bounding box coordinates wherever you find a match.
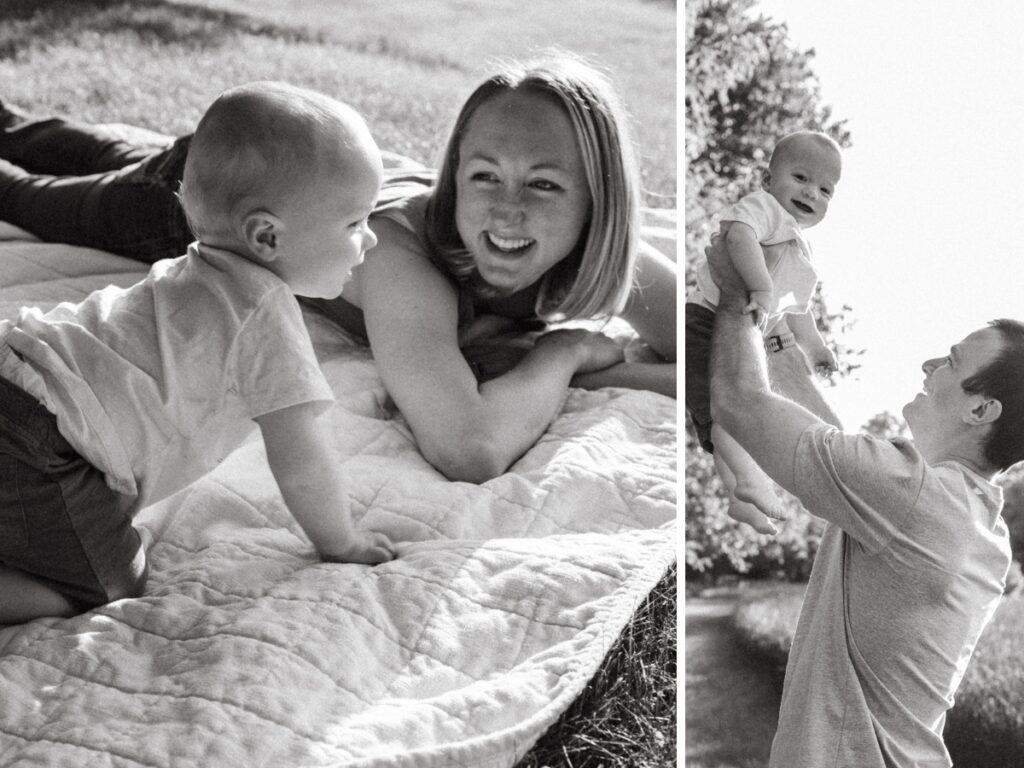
[178,82,366,238]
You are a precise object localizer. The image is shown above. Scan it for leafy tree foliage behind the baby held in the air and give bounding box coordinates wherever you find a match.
[685,0,860,580]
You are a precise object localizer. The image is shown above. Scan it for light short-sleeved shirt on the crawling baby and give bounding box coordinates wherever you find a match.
[0,243,334,509]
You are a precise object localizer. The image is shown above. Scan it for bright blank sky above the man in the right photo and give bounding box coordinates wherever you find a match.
[755,0,1024,429]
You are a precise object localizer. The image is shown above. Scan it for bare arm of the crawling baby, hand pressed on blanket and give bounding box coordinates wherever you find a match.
[256,402,394,564]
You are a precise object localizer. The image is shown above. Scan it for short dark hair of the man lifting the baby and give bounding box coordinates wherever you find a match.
[961,319,1024,472]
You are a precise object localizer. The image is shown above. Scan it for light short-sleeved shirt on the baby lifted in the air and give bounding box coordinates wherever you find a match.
[689,189,818,328]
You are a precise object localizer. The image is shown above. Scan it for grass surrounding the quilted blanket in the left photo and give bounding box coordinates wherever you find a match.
[0,0,677,768]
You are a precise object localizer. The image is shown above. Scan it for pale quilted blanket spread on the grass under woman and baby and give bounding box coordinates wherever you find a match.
[0,219,676,768]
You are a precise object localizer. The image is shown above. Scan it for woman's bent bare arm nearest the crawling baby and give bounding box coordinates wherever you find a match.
[350,220,622,482]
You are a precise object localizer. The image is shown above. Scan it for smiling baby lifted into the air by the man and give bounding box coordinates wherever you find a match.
[686,131,842,534]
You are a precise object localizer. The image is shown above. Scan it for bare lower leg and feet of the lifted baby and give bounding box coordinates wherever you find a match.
[712,424,787,534]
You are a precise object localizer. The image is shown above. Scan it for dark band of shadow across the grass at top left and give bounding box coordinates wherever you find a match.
[0,0,464,70]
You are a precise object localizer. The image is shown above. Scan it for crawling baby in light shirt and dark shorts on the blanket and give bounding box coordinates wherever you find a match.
[0,83,394,625]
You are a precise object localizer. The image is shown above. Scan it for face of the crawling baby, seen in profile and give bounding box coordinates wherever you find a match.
[271,145,382,299]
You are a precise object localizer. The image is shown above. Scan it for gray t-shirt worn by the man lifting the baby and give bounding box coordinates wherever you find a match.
[770,424,1011,768]
